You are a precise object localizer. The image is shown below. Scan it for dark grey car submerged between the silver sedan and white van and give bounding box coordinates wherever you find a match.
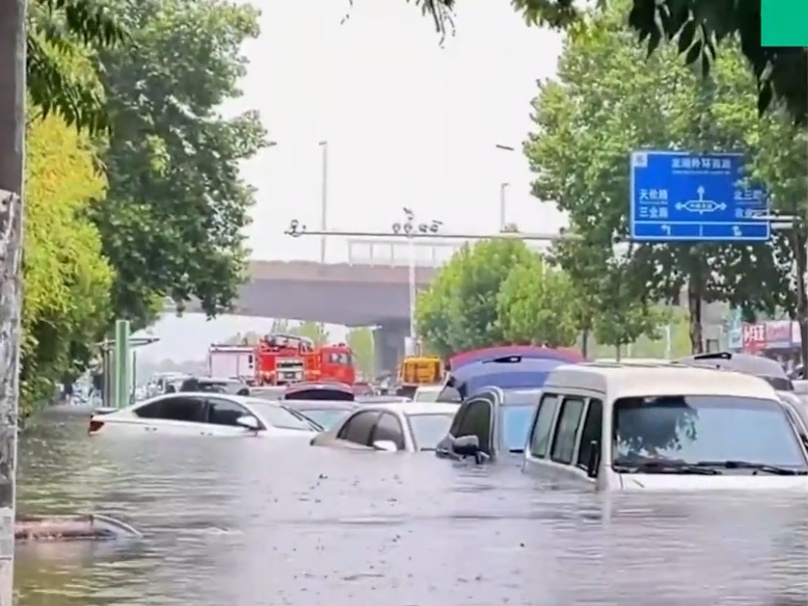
[435,387,542,462]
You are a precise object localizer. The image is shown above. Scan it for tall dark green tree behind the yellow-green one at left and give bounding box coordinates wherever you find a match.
[87,0,266,325]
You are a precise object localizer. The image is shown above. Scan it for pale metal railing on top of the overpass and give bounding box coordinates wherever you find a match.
[348,238,550,267]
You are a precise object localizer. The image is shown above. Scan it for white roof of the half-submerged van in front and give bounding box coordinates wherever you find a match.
[544,362,777,400]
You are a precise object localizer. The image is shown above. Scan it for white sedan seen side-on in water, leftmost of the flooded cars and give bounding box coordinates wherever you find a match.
[89,392,322,438]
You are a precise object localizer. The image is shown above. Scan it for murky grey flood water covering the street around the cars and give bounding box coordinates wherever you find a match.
[16,415,808,606]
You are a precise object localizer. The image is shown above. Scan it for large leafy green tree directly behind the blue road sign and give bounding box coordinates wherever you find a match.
[525,2,789,351]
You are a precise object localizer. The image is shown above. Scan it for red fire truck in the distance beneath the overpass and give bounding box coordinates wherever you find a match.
[255,333,356,385]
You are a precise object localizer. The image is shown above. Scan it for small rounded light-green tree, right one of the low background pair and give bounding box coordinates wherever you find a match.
[497,255,579,347]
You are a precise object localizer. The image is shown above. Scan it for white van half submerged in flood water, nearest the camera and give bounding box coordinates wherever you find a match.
[523,363,808,492]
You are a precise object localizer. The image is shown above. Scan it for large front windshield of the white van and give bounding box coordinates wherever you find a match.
[613,396,806,469]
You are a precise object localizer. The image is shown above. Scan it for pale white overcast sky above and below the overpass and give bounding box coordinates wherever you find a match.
[141,0,564,359]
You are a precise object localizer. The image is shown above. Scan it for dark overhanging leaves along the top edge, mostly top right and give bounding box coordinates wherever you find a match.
[412,0,808,125]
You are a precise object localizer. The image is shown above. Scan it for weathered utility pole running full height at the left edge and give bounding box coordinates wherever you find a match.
[0,0,26,606]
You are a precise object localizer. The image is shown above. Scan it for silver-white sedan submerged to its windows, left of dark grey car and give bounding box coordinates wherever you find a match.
[311,402,458,452]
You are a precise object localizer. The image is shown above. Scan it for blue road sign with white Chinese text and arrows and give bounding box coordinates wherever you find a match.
[630,151,771,242]
